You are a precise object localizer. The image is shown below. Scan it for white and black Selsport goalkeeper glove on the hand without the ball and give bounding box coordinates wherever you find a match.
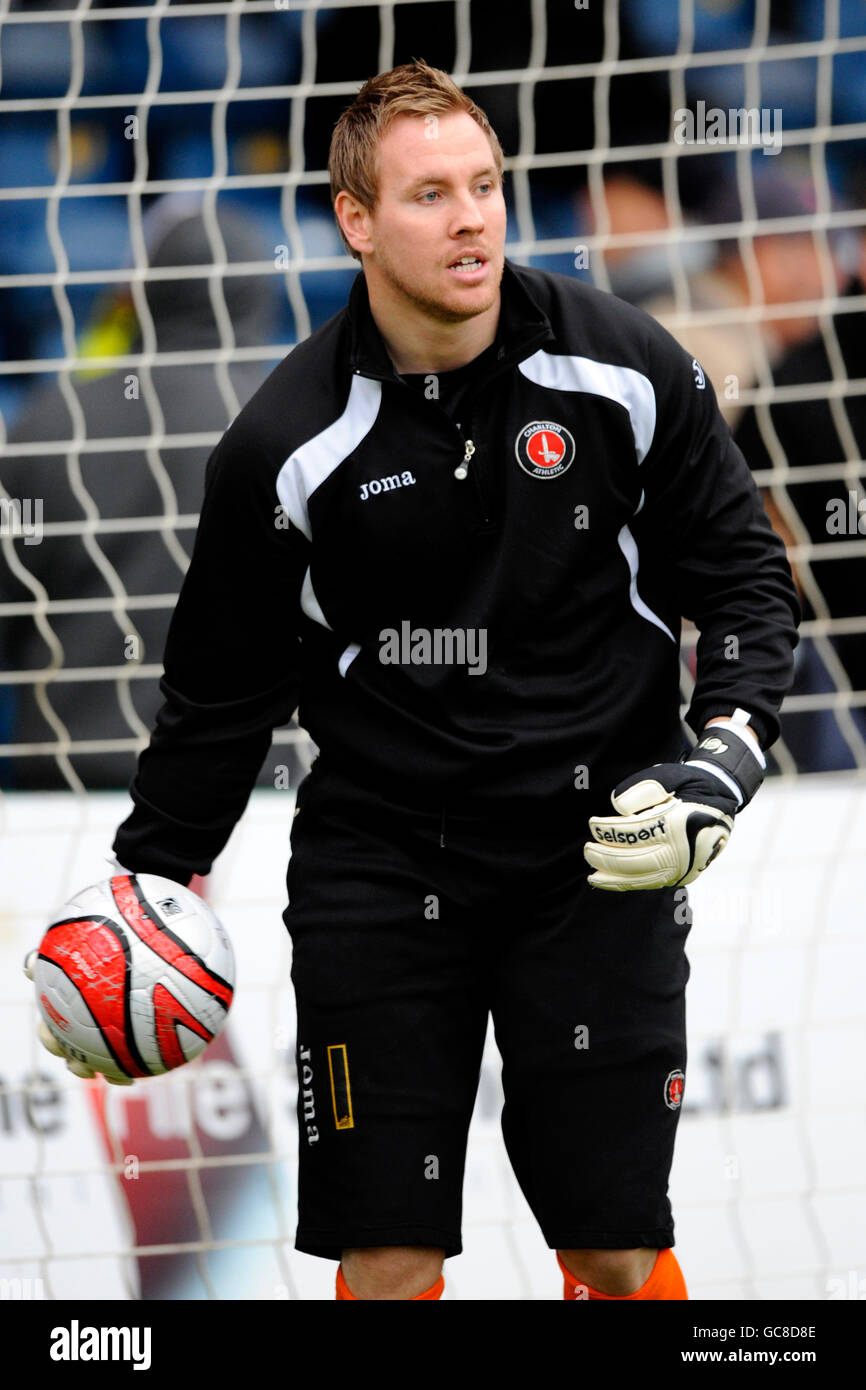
[584,710,766,892]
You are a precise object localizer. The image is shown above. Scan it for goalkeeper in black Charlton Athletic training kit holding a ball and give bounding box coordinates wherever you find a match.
[103,63,796,1300]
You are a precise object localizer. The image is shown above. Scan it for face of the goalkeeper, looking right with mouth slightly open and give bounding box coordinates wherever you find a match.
[363,111,506,322]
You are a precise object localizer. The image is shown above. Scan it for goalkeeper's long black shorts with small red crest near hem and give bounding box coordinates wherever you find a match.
[285,769,688,1259]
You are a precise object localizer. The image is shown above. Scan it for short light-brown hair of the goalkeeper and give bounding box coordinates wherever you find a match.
[328,58,503,260]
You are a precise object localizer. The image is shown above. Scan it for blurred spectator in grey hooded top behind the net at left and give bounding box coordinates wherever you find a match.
[0,195,291,790]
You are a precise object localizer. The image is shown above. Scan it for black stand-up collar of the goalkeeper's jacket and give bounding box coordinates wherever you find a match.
[348,260,553,381]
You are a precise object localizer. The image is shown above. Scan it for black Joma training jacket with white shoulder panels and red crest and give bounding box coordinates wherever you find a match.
[114,263,798,880]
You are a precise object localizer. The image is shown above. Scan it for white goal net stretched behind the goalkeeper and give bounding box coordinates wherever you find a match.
[0,0,866,1300]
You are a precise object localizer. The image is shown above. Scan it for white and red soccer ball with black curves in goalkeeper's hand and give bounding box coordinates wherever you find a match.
[28,873,235,1081]
